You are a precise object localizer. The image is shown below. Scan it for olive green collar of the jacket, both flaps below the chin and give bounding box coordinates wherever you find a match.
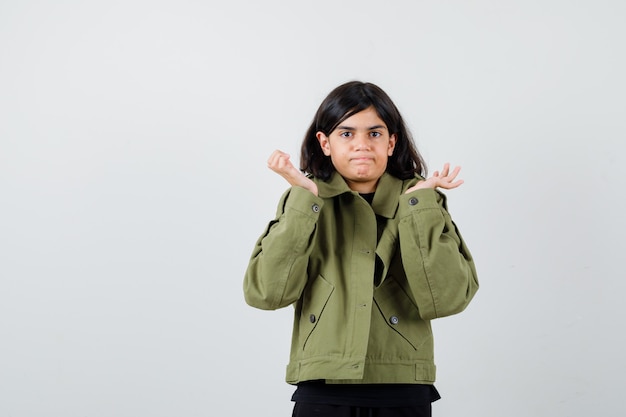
[315,172,403,219]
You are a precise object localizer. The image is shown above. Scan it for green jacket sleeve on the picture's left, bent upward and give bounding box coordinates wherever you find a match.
[244,187,323,310]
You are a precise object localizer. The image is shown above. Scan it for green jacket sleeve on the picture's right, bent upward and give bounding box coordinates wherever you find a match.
[398,189,478,320]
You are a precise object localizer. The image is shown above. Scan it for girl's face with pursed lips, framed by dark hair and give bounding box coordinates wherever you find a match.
[317,107,396,193]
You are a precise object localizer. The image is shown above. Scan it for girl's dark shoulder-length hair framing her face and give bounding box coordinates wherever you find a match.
[300,81,426,180]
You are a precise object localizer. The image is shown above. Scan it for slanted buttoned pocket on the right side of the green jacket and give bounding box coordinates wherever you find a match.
[374,276,432,350]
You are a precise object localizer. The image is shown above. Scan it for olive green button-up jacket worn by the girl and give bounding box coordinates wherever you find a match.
[244,173,478,384]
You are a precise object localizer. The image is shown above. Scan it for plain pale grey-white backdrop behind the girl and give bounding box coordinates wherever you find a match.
[0,0,626,417]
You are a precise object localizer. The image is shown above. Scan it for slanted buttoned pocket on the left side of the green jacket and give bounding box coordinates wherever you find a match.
[299,275,335,350]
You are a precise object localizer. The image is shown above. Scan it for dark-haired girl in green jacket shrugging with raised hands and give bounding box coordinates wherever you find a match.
[244,81,478,417]
